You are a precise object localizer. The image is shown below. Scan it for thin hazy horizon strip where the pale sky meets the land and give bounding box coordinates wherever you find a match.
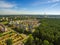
[0,14,60,16]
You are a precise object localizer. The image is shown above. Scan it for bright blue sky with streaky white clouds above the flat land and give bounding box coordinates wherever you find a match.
[0,0,60,15]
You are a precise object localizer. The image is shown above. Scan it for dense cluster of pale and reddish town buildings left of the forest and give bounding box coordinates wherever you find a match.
[9,19,39,31]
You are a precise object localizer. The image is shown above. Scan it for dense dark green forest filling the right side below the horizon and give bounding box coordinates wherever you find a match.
[24,18,60,45]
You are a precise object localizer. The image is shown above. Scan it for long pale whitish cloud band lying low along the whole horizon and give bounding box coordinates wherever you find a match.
[0,9,60,15]
